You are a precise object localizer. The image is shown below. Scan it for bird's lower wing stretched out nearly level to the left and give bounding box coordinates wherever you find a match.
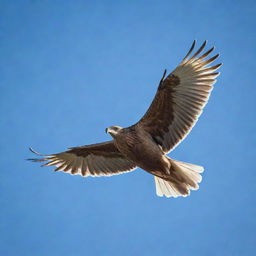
[28,141,136,176]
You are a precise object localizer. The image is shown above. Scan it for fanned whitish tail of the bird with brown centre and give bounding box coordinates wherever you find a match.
[155,158,204,197]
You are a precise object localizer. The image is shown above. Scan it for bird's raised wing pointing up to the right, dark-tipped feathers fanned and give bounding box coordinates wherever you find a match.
[136,41,221,152]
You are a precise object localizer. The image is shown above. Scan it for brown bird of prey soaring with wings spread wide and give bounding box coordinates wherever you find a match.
[28,40,222,198]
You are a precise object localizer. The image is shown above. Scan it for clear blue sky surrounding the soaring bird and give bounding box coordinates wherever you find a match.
[0,0,256,256]
